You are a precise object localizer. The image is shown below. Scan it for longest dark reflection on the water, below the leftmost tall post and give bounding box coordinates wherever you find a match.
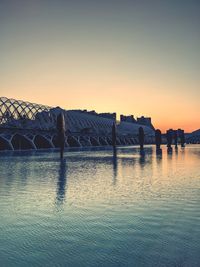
[56,159,67,204]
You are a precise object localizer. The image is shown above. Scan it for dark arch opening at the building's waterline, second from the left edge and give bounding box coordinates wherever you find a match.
[11,134,34,150]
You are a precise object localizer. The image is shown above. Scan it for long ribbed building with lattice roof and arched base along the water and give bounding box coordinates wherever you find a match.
[0,98,154,150]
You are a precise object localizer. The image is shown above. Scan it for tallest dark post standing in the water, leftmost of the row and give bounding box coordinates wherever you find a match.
[57,112,65,159]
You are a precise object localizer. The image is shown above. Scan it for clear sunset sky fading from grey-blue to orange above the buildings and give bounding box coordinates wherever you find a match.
[0,0,200,132]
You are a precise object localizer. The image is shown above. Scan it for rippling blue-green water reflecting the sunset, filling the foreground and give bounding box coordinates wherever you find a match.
[0,145,200,267]
